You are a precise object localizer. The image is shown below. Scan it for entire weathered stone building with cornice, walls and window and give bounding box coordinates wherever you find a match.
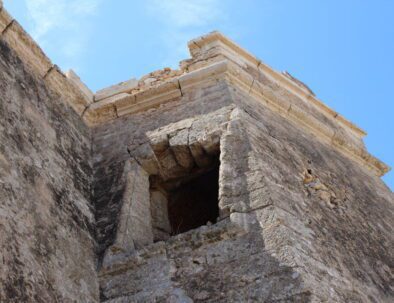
[0,7,394,303]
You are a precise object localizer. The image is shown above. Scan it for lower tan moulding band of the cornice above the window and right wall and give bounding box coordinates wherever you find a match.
[84,60,389,176]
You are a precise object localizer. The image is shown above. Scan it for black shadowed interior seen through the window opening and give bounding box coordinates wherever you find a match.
[168,165,219,235]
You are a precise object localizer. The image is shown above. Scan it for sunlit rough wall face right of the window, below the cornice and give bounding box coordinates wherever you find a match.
[228,91,394,302]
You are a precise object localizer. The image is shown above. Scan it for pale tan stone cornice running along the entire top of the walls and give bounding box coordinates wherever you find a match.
[0,2,389,176]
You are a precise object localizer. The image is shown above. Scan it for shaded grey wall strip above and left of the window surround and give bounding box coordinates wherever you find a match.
[93,81,231,264]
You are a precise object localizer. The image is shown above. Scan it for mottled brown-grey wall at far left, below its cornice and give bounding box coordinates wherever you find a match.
[0,40,98,302]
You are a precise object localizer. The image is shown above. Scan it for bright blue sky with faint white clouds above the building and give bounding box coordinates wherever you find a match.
[4,0,394,190]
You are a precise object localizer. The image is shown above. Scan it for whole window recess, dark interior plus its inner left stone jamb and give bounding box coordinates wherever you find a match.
[150,157,219,241]
